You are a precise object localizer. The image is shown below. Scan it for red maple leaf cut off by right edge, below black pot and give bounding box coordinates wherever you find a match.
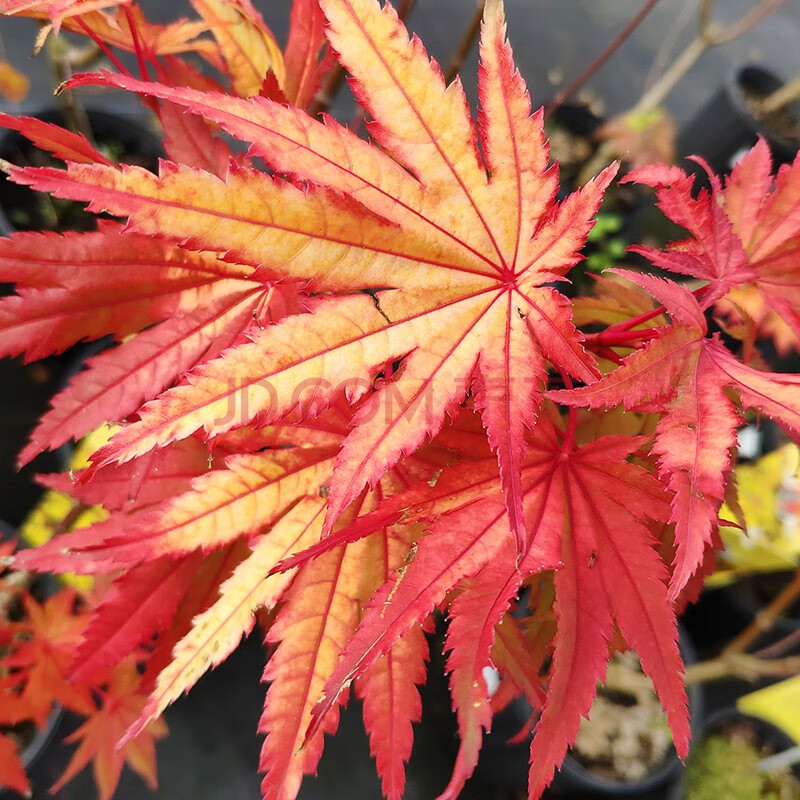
[625,139,800,336]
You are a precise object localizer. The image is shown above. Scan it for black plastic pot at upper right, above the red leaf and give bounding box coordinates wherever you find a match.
[677,65,800,174]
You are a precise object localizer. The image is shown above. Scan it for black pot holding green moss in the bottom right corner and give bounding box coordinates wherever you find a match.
[667,708,800,800]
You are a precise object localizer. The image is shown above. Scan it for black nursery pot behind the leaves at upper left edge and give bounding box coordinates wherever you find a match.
[0,108,163,234]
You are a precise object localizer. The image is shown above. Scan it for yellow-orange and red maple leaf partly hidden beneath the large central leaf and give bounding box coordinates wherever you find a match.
[74,409,454,797]
